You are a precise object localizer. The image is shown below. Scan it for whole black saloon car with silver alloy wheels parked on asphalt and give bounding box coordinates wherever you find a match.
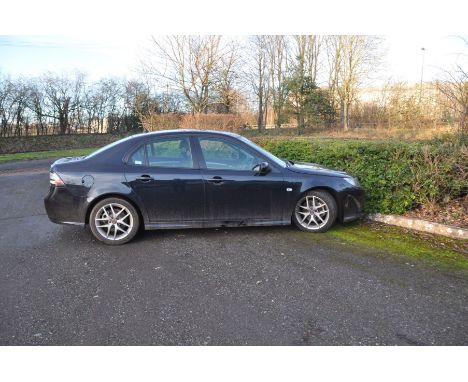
[45,130,363,244]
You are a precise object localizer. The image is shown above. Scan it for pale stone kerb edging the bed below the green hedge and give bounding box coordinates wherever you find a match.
[368,214,468,240]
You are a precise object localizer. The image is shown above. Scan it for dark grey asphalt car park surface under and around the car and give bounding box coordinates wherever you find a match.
[0,161,468,345]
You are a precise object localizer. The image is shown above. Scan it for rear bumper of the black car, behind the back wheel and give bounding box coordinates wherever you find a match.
[44,186,86,226]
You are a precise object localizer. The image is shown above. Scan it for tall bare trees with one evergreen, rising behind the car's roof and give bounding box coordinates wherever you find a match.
[142,35,380,130]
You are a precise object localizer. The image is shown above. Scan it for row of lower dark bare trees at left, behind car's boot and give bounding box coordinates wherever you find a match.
[0,72,155,136]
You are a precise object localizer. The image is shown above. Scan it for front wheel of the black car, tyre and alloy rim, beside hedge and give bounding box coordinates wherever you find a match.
[292,190,338,232]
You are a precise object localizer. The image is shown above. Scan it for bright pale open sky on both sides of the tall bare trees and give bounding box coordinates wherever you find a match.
[0,34,468,82]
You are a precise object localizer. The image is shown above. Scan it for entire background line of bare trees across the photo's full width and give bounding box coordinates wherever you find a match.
[0,35,468,136]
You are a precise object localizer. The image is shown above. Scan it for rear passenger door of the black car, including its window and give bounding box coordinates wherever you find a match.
[125,134,205,227]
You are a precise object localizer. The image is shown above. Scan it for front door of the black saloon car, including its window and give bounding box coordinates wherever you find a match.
[198,136,286,224]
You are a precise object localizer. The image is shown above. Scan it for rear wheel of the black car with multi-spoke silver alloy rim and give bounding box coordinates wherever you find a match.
[89,198,140,245]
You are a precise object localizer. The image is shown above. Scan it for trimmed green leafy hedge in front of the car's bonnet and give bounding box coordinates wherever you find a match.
[254,138,468,214]
